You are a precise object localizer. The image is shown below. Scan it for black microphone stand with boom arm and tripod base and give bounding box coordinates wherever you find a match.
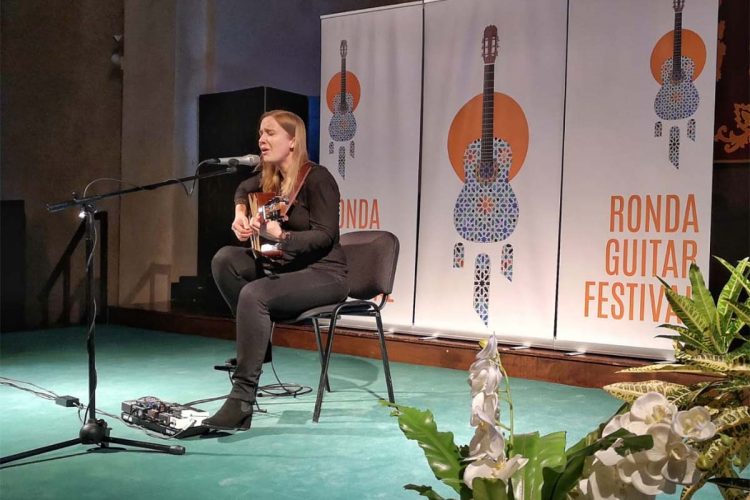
[0,164,237,464]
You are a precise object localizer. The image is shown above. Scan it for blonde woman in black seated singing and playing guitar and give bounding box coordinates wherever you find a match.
[204,110,349,430]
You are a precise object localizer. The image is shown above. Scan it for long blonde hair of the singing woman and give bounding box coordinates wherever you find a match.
[260,109,308,196]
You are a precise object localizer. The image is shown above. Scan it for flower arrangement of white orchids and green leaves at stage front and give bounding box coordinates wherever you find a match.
[384,258,750,500]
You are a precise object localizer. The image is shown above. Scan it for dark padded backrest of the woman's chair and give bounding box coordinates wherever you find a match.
[341,231,399,300]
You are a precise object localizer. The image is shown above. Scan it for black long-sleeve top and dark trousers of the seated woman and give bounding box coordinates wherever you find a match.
[211,165,349,401]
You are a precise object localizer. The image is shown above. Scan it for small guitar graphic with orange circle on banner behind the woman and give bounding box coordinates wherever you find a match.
[326,40,360,179]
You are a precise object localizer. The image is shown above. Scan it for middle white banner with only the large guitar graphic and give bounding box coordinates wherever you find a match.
[415,0,567,344]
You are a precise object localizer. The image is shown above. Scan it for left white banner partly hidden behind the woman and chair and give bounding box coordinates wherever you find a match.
[320,2,422,327]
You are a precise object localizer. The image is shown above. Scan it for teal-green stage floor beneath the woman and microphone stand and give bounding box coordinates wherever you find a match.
[0,326,720,500]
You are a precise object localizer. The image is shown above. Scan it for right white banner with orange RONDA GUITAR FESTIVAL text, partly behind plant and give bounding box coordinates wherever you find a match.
[557,0,717,354]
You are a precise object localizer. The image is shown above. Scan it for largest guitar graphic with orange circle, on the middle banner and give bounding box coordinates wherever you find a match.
[448,25,529,325]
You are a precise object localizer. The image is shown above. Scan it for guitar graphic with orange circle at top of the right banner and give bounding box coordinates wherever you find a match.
[651,0,706,168]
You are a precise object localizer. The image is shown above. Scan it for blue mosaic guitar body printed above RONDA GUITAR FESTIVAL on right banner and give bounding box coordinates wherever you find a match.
[654,56,700,120]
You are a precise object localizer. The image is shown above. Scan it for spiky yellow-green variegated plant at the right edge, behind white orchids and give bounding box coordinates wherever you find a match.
[604,257,750,498]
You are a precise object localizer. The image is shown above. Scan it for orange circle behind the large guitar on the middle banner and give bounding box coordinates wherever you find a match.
[448,92,529,182]
